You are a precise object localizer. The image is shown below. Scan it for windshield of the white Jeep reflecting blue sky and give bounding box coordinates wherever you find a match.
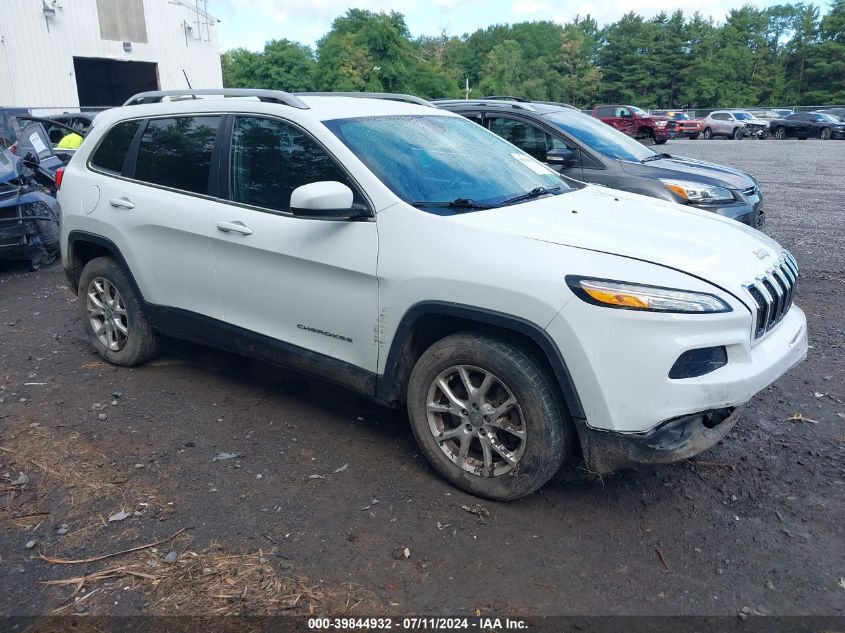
[324,115,569,212]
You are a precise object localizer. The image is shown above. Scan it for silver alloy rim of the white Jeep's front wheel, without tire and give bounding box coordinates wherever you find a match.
[426,365,526,477]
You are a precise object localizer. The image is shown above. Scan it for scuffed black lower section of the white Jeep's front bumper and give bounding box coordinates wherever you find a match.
[579,407,742,474]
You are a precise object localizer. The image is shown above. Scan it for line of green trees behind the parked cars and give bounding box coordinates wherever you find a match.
[222,0,845,108]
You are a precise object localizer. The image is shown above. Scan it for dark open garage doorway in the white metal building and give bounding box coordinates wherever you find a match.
[73,57,159,107]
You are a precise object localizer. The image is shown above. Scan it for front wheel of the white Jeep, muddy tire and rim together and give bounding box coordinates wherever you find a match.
[407,332,573,501]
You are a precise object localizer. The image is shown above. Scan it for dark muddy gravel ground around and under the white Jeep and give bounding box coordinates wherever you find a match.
[0,140,845,616]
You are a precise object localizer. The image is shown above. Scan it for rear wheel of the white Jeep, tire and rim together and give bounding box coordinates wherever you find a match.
[79,257,158,367]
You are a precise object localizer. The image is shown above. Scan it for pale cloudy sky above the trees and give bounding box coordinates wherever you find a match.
[207,0,828,51]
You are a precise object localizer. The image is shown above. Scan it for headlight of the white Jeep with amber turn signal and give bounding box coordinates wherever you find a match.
[566,275,731,314]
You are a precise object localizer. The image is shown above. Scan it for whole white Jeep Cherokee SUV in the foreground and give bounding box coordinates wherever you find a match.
[59,90,807,500]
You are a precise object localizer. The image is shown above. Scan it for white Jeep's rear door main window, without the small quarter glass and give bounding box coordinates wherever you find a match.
[135,116,221,194]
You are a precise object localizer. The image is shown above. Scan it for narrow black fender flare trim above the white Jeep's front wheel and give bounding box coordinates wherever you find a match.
[376,301,585,421]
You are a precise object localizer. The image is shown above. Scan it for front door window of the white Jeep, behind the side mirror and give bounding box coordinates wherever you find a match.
[229,116,362,212]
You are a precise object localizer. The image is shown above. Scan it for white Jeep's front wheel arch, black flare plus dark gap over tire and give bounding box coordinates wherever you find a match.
[376,301,585,420]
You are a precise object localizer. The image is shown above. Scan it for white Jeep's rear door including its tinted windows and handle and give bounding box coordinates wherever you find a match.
[91,114,223,318]
